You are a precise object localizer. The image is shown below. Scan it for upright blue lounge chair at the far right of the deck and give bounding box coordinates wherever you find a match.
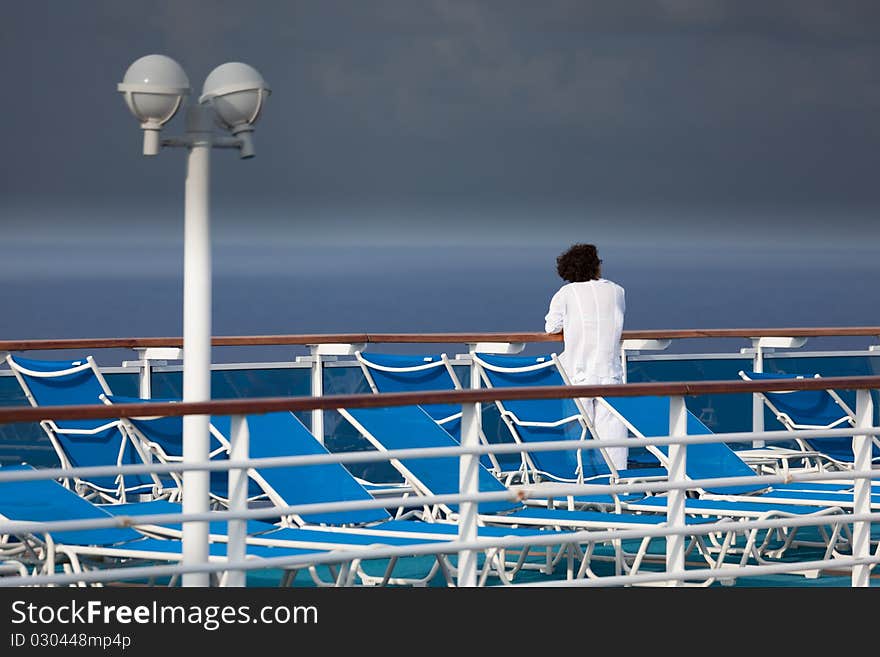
[739,370,880,470]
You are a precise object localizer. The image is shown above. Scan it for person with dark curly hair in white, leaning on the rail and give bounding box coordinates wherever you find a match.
[544,244,628,470]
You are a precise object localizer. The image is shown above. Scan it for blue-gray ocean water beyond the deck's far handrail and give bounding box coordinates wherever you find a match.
[0,244,880,364]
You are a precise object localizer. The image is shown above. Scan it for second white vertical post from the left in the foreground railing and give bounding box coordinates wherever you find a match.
[458,402,480,587]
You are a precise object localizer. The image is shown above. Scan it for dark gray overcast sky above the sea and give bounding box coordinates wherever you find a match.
[0,0,880,246]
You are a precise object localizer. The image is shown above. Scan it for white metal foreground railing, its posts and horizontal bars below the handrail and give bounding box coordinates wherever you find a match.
[0,398,880,586]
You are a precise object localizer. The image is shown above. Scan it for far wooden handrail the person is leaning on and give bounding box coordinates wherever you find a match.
[0,326,880,351]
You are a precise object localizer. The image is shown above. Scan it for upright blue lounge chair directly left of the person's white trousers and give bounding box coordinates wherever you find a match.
[474,354,665,483]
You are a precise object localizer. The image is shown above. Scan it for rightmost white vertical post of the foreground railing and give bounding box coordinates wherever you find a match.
[852,390,874,586]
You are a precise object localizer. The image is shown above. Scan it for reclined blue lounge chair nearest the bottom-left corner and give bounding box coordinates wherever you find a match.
[0,466,326,583]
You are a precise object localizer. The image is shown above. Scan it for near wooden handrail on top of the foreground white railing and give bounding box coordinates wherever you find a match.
[0,376,880,424]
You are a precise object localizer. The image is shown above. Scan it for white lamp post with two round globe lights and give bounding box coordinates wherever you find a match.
[117,55,270,586]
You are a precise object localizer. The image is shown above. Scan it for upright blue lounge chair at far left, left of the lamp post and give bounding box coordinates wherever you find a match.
[6,354,168,501]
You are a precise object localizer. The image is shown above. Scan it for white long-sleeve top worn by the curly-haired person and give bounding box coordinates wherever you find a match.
[544,278,626,384]
